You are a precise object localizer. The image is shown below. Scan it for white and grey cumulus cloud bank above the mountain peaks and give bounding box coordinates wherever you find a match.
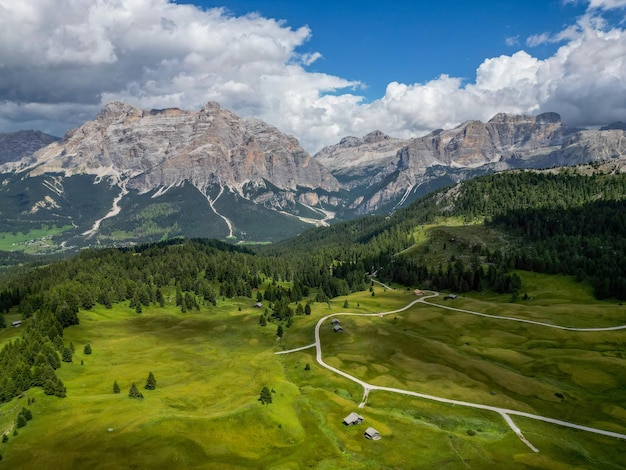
[0,0,626,152]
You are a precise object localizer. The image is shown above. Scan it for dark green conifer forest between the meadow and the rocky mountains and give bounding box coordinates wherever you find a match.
[0,169,626,403]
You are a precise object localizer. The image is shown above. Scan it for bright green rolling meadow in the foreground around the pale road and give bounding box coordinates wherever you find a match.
[0,273,626,469]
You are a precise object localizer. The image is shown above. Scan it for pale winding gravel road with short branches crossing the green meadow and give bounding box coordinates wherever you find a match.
[276,292,626,452]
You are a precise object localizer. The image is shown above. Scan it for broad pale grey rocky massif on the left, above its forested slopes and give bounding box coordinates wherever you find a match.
[23,103,339,199]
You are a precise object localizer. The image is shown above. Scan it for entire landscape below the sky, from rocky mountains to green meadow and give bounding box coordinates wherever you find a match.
[0,103,626,469]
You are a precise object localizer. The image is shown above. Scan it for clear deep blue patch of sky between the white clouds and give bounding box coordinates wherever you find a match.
[186,0,587,100]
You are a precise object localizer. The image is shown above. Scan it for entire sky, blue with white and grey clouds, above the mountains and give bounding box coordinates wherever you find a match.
[0,0,626,154]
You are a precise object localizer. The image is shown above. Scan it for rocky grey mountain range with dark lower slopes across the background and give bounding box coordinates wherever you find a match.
[0,102,626,248]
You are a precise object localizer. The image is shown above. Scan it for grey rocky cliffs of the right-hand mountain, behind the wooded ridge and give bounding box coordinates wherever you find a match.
[315,113,626,214]
